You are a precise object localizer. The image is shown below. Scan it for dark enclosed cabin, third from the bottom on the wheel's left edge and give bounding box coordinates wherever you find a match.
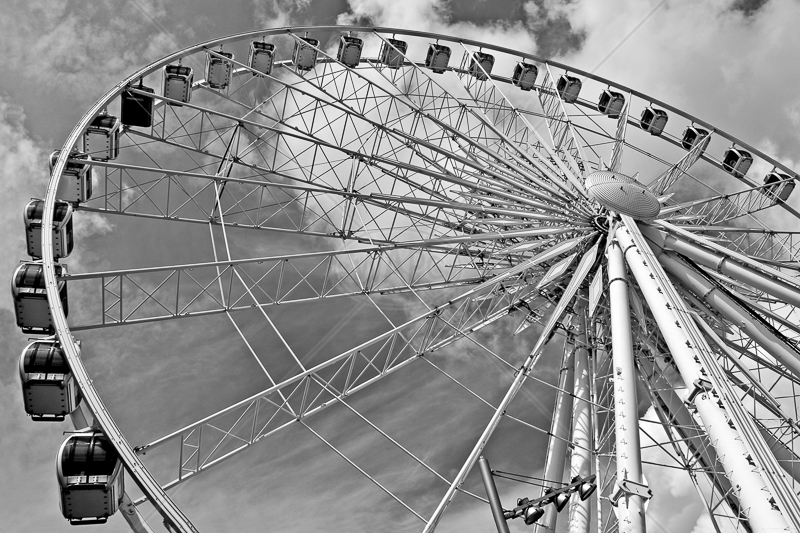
[11,262,69,335]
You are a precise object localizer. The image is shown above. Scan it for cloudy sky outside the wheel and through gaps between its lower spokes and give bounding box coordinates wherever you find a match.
[0,0,800,533]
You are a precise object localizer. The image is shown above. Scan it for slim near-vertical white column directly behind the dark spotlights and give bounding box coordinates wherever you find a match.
[568,305,593,533]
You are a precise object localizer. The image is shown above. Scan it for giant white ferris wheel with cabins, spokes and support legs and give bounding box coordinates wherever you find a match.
[12,26,800,533]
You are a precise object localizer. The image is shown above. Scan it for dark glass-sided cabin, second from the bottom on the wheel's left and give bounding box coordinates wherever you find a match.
[19,339,81,422]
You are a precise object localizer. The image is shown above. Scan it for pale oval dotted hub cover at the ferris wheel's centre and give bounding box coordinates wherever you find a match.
[586,170,661,220]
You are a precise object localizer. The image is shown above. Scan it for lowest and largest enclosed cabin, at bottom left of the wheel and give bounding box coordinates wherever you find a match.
[56,432,125,525]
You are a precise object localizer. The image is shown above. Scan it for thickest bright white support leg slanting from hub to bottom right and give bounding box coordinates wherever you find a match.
[615,222,788,533]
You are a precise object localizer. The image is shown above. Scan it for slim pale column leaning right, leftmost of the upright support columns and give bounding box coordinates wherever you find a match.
[536,339,576,531]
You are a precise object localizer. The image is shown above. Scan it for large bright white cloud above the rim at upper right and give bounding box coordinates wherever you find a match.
[528,0,800,161]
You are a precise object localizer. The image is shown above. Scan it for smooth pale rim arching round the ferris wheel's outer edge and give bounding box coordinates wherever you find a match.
[42,22,798,531]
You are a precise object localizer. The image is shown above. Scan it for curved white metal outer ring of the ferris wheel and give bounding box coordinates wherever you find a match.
[42,26,800,532]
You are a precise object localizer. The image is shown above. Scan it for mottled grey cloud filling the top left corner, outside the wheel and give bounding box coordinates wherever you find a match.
[0,0,191,105]
